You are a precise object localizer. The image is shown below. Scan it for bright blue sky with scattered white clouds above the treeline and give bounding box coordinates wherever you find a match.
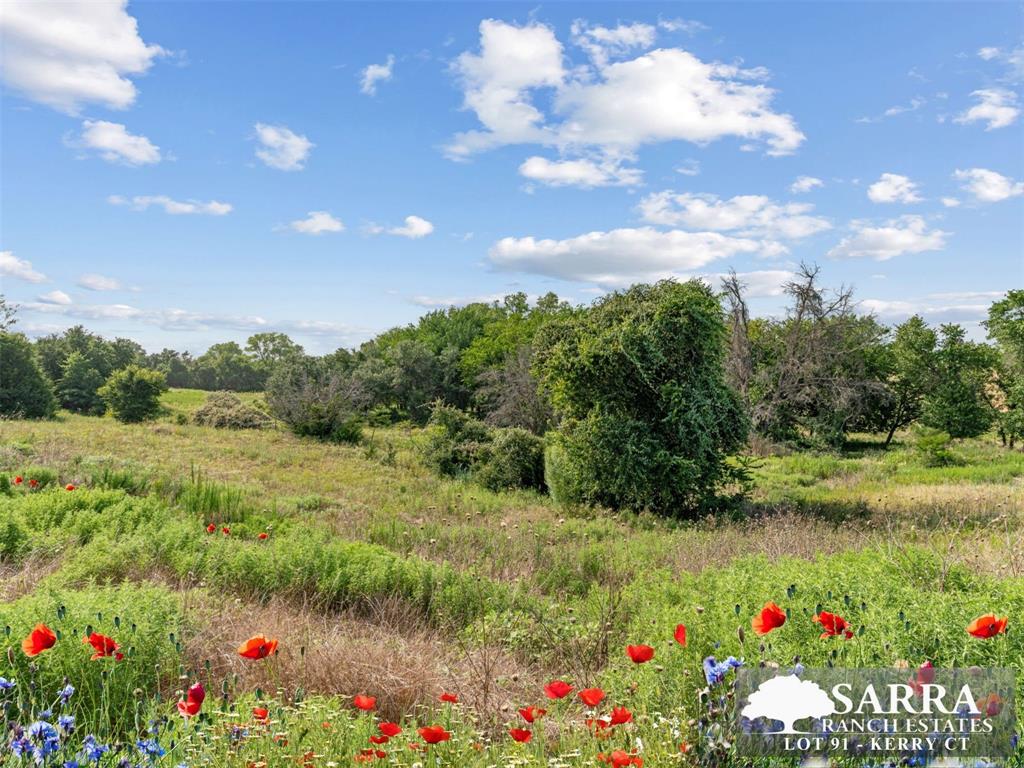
[0,0,1024,352]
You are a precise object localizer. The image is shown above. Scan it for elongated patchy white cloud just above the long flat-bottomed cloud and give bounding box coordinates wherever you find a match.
[640,191,831,240]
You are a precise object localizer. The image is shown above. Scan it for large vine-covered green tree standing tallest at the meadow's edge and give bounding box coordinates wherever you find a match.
[538,281,746,515]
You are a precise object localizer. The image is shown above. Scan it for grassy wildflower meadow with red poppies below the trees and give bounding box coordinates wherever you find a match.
[0,390,1024,768]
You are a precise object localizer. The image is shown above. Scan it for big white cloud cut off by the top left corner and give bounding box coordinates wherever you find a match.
[0,0,166,115]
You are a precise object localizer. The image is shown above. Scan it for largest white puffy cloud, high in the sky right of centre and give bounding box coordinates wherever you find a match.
[446,19,804,159]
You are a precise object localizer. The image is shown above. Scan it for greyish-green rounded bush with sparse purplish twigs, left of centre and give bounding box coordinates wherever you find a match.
[266,357,366,442]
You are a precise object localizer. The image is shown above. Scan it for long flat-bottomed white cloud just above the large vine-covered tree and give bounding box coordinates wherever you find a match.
[488,226,764,287]
